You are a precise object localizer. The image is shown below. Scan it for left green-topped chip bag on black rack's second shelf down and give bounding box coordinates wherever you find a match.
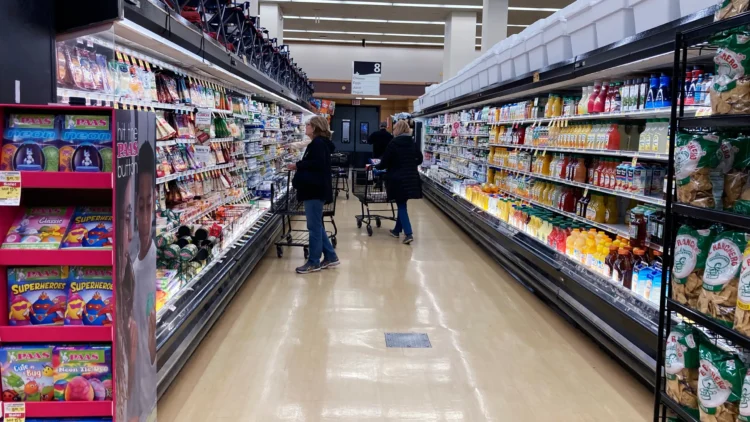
[674,133,721,208]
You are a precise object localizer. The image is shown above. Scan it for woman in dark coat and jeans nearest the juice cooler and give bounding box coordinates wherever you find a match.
[376,120,422,245]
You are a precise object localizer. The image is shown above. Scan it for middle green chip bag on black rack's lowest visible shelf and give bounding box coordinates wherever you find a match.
[698,341,746,421]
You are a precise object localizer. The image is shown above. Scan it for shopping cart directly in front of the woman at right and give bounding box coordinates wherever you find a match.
[352,166,396,236]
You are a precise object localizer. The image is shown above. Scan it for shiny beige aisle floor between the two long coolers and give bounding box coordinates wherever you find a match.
[159,197,651,422]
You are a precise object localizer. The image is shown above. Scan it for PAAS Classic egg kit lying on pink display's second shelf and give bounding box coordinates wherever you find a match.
[2,207,73,249]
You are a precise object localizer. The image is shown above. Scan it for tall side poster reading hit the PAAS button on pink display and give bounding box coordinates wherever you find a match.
[114,110,157,422]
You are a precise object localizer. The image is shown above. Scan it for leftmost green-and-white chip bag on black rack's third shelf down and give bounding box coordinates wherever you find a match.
[672,224,714,309]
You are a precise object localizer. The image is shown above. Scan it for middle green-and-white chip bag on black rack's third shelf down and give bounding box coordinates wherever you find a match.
[698,230,748,328]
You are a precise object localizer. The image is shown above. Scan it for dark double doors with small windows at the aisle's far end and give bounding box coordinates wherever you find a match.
[331,105,380,168]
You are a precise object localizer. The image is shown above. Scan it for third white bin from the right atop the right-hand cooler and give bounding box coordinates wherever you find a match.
[591,0,636,47]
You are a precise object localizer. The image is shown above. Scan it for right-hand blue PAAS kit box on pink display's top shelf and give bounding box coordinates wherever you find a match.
[60,114,112,172]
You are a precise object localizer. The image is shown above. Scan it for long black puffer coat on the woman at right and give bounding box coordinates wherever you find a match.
[376,135,422,202]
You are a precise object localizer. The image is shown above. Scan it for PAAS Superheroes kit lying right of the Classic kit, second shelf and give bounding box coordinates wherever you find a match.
[60,207,113,249]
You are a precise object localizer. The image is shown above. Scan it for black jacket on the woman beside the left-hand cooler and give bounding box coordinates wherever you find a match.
[292,136,336,204]
